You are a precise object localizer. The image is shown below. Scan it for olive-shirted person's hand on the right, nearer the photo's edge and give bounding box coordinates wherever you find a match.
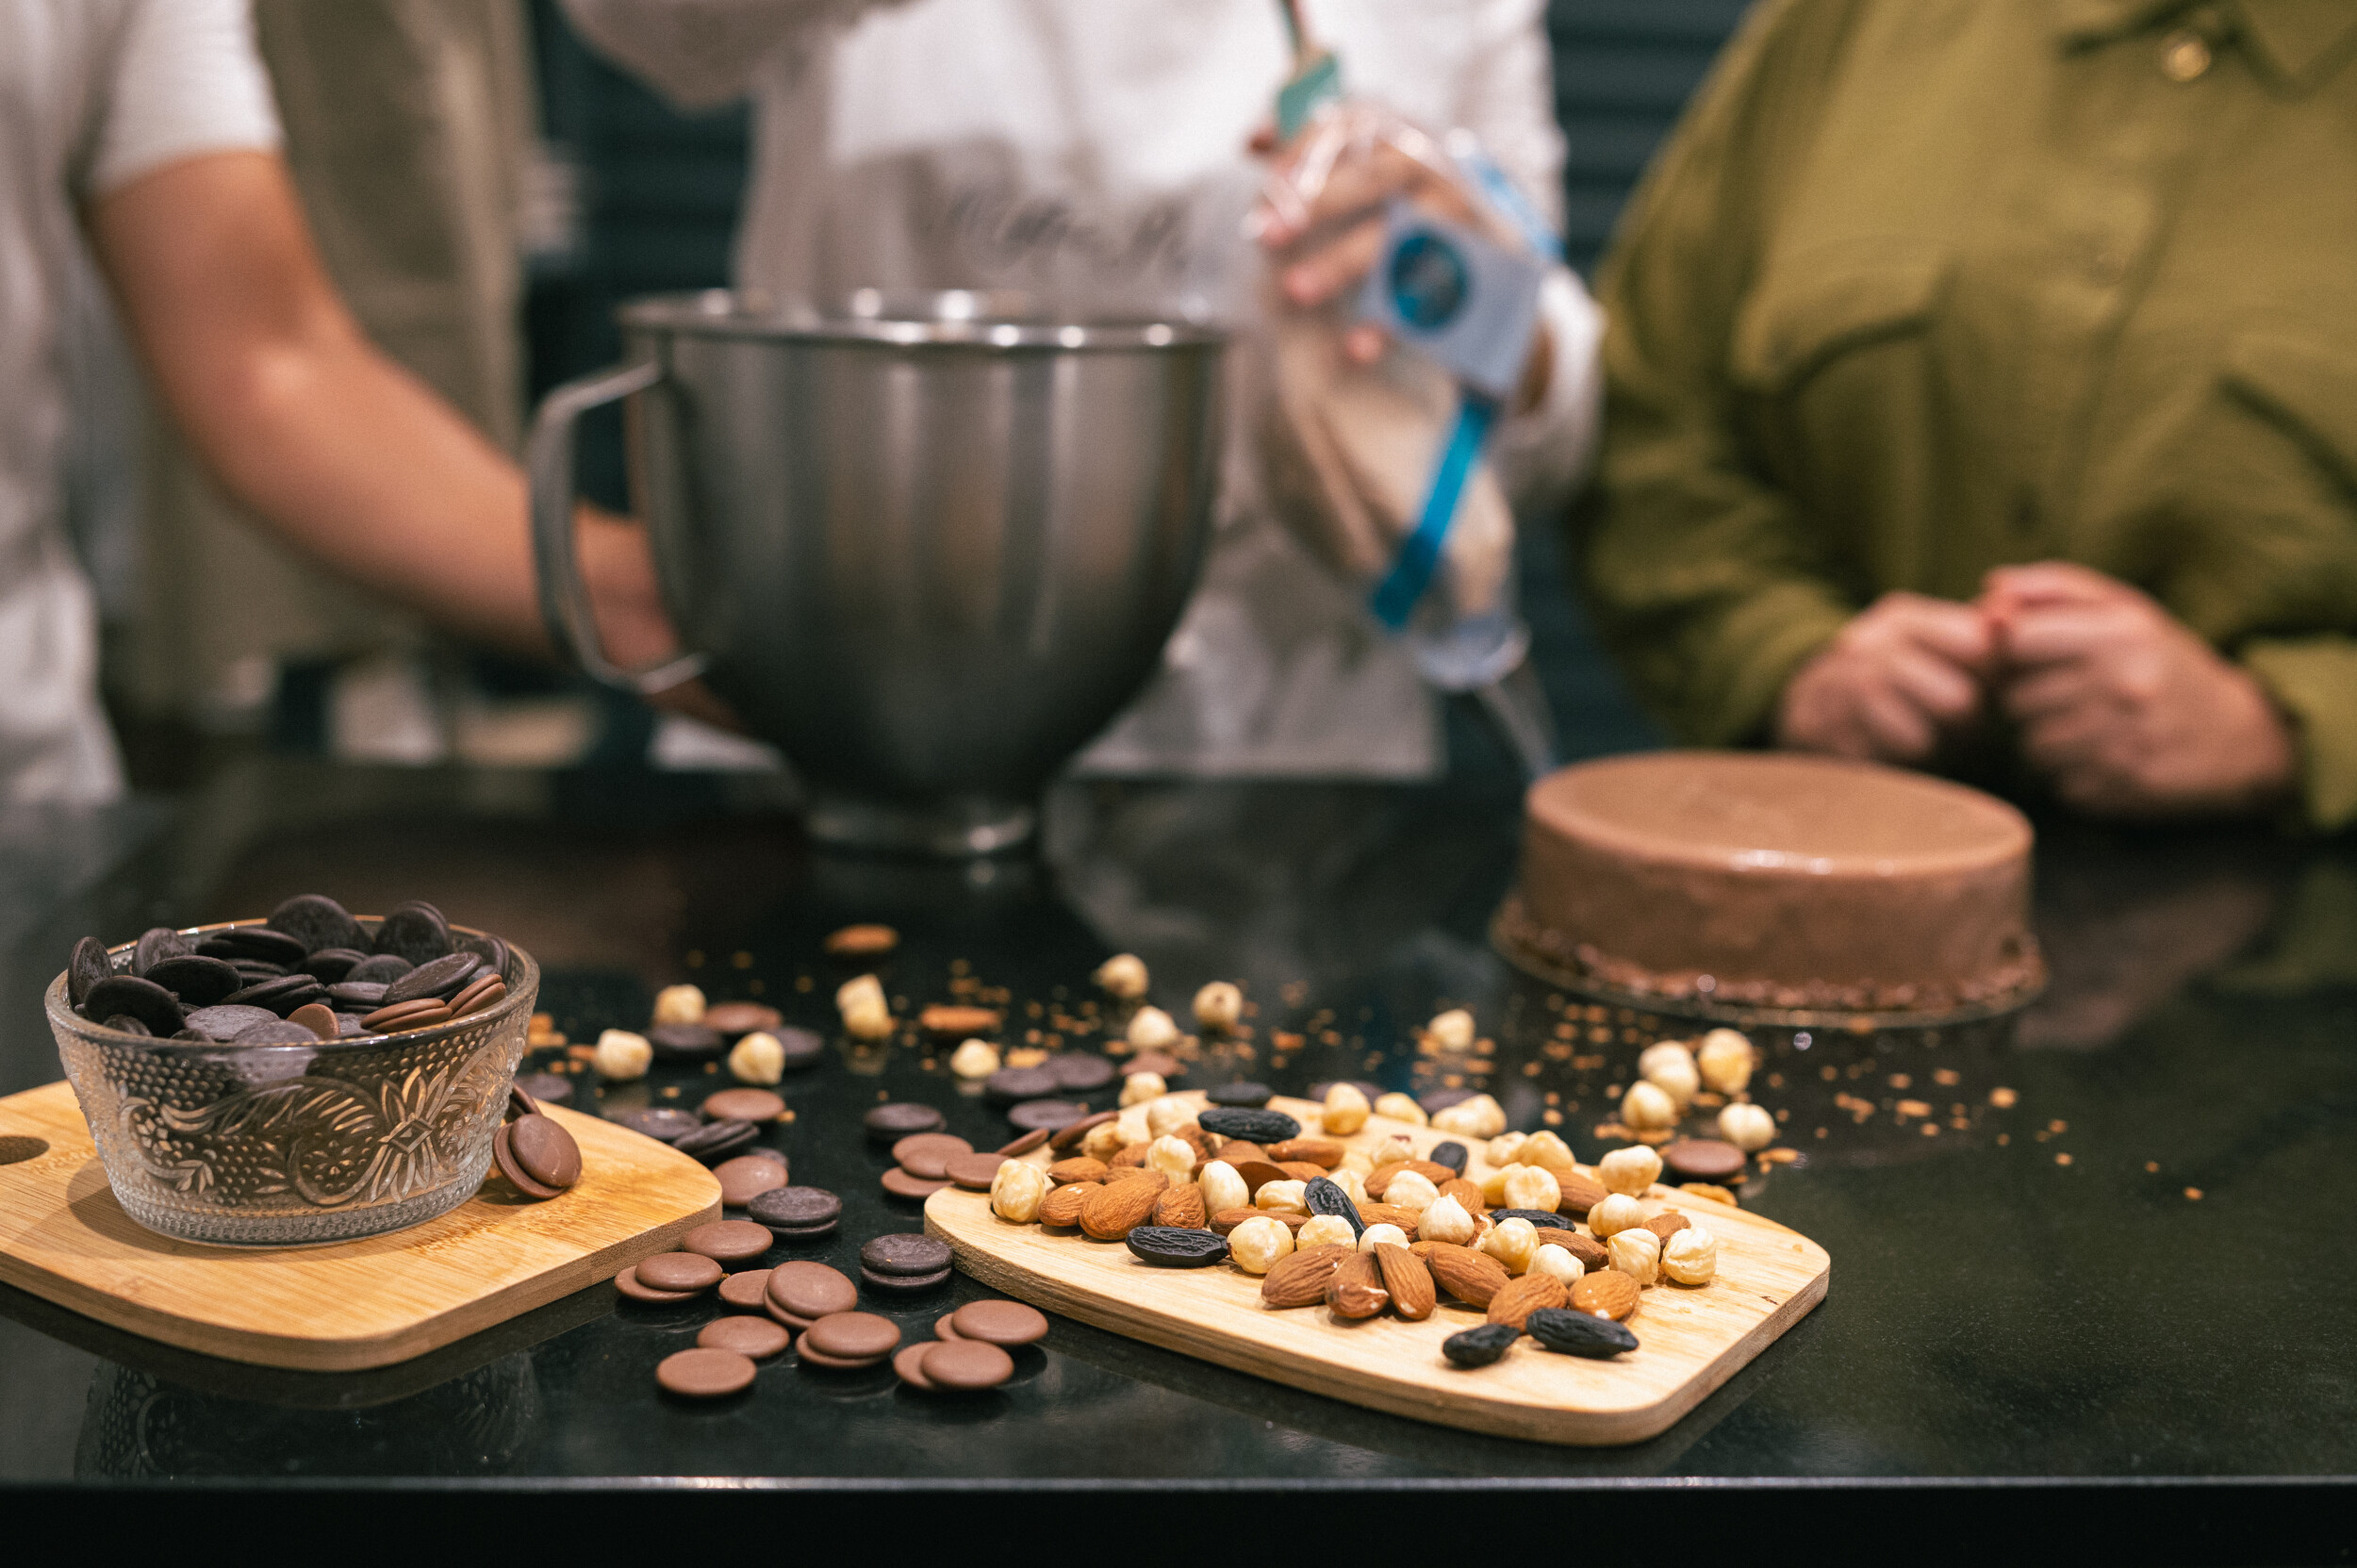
[1980,561,2299,816]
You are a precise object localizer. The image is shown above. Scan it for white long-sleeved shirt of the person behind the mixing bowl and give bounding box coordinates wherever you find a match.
[566,0,1601,778]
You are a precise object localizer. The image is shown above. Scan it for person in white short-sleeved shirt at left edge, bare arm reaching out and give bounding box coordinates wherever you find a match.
[0,0,674,804]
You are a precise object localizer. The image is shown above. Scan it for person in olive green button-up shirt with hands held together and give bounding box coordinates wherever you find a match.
[1579,0,2357,828]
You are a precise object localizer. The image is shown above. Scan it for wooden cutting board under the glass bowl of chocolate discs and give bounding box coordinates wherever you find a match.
[0,1082,721,1372]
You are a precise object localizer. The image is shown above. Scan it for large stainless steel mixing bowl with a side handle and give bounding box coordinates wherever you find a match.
[531,292,1224,853]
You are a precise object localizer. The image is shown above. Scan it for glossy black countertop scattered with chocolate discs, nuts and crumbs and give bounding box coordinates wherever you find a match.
[0,762,2357,1537]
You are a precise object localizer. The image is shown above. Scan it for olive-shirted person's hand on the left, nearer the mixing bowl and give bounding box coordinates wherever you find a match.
[1775,594,1994,764]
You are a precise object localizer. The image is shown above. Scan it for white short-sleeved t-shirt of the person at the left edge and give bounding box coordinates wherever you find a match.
[0,0,278,804]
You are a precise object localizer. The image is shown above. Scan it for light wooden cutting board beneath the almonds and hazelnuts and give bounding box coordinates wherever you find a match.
[924,1094,1832,1445]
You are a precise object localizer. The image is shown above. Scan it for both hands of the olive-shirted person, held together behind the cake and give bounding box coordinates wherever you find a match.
[1775,561,2299,818]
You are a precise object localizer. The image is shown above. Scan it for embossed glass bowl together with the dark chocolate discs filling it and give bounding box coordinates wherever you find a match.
[45,894,540,1245]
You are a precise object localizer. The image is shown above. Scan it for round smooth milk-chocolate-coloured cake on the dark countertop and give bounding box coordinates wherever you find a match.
[1497,752,2046,1014]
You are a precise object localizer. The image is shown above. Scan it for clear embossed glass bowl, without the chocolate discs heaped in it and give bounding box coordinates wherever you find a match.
[42,915,540,1247]
